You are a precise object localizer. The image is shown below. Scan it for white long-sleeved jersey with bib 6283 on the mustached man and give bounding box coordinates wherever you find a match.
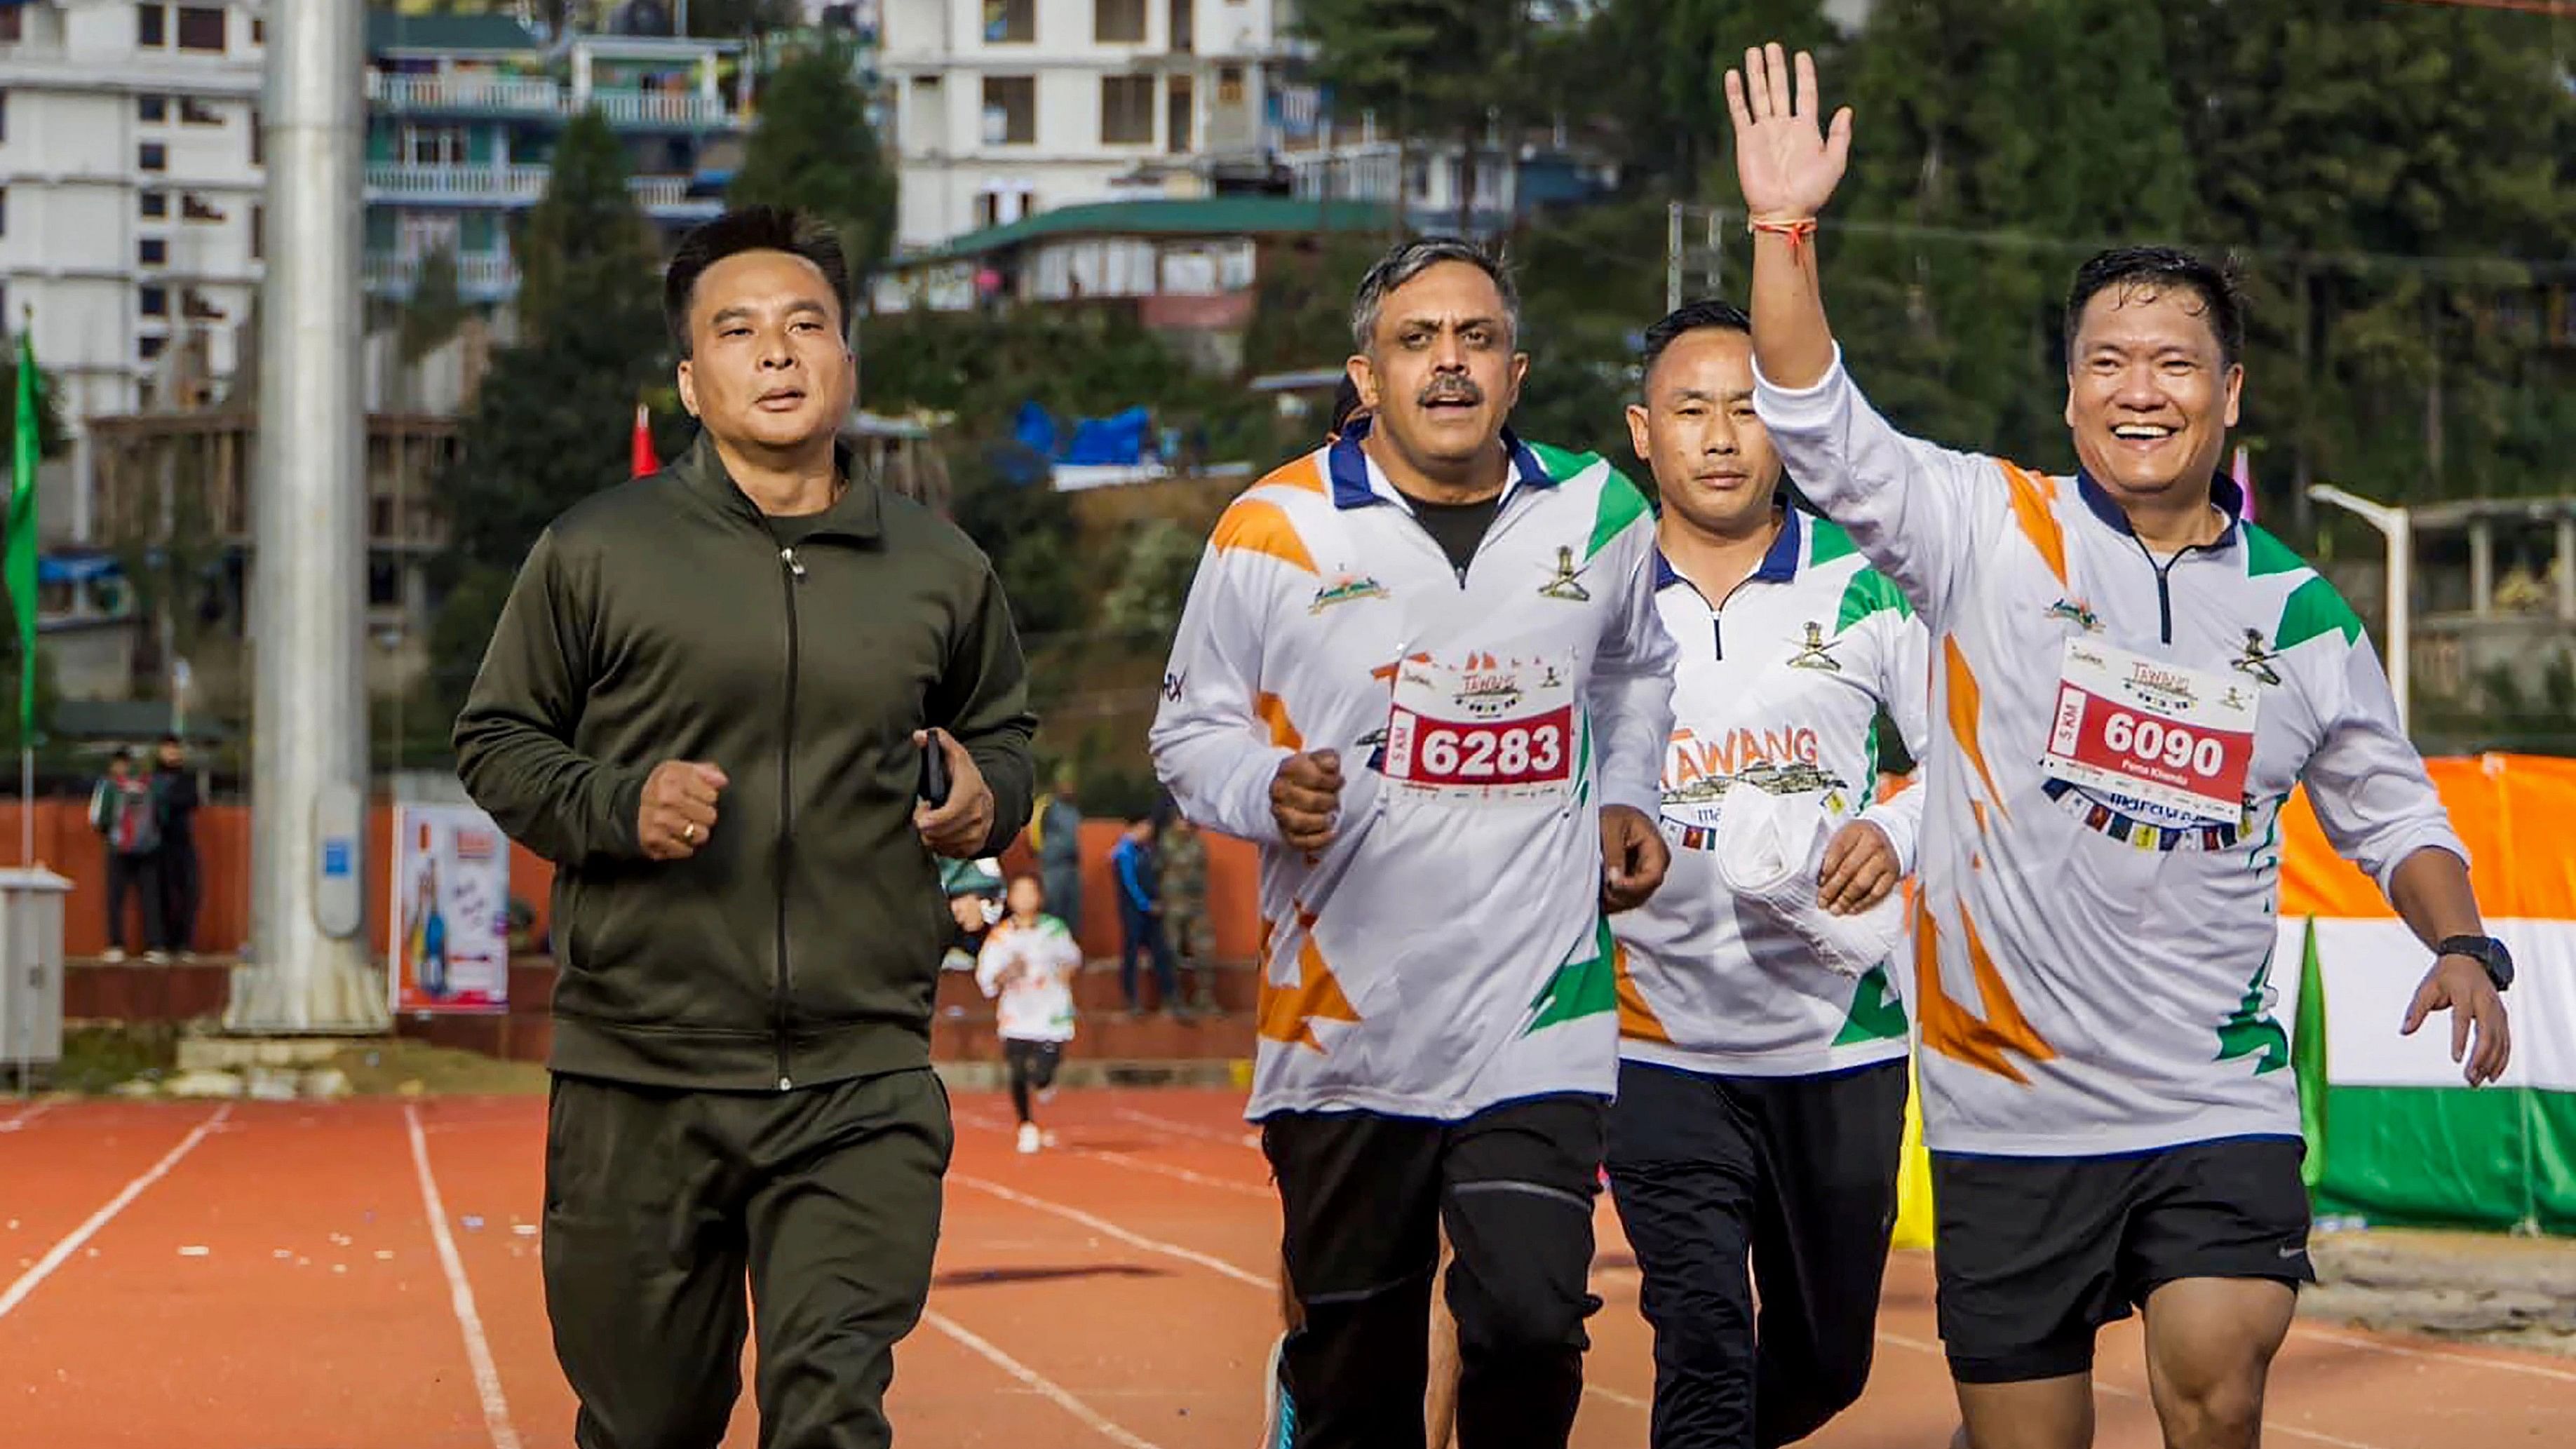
[1152,422,1672,1121]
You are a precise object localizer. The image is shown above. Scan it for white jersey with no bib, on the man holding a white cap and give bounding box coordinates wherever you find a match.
[1610,511,1924,1078]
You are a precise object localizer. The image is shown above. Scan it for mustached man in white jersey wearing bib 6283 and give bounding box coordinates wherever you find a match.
[1152,240,1672,1449]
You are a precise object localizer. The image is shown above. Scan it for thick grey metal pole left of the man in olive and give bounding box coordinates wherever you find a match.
[224,0,389,1031]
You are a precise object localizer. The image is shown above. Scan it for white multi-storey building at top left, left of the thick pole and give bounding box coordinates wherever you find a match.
[0,0,265,451]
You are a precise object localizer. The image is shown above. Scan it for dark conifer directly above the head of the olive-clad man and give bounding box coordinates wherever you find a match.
[727,41,894,281]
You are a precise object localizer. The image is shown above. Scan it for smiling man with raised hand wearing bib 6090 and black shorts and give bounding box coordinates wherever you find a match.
[1726,46,2511,1449]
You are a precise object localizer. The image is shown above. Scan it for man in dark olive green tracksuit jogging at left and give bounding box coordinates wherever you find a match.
[456,209,1033,1449]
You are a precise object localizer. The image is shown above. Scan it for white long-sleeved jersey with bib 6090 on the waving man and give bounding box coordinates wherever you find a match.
[1754,356,2468,1158]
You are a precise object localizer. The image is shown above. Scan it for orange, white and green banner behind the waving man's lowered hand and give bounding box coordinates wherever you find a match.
[2272,755,2576,1232]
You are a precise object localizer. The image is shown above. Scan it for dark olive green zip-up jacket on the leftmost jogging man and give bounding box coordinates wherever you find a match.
[456,436,1036,1091]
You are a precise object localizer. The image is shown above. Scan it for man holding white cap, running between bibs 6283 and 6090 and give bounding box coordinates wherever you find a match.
[1610,302,1924,1449]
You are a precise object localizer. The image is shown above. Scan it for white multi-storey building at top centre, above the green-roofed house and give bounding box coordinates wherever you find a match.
[878,0,1288,248]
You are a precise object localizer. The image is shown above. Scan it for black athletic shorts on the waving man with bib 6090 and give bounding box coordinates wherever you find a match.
[1932,1137,2316,1384]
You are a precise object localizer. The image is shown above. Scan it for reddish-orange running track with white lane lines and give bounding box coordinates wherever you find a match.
[0,1091,2576,1449]
